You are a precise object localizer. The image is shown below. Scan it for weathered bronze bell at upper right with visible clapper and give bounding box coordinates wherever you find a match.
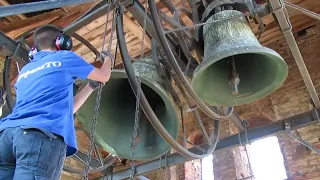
[192,10,288,106]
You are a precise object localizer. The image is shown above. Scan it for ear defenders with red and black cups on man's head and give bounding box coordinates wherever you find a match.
[29,25,72,60]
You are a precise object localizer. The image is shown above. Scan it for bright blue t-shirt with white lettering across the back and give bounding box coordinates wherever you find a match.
[0,51,94,156]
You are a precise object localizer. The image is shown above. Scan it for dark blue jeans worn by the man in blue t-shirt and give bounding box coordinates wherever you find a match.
[0,127,66,180]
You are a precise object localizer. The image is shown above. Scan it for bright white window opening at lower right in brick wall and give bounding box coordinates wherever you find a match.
[248,136,287,180]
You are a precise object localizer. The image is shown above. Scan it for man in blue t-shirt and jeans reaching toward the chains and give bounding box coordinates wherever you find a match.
[0,26,113,180]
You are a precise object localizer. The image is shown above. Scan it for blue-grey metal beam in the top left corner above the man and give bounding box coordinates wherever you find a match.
[0,0,95,17]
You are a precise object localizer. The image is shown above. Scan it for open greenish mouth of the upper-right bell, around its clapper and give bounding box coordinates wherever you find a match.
[191,46,288,106]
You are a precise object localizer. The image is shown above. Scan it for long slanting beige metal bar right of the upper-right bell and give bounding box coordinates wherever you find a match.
[269,0,320,108]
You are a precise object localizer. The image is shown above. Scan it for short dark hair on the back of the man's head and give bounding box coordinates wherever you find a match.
[33,25,62,51]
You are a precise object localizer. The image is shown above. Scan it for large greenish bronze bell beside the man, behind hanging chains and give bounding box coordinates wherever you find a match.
[76,59,179,160]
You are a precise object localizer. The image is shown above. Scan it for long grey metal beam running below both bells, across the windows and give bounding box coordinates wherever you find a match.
[97,110,319,180]
